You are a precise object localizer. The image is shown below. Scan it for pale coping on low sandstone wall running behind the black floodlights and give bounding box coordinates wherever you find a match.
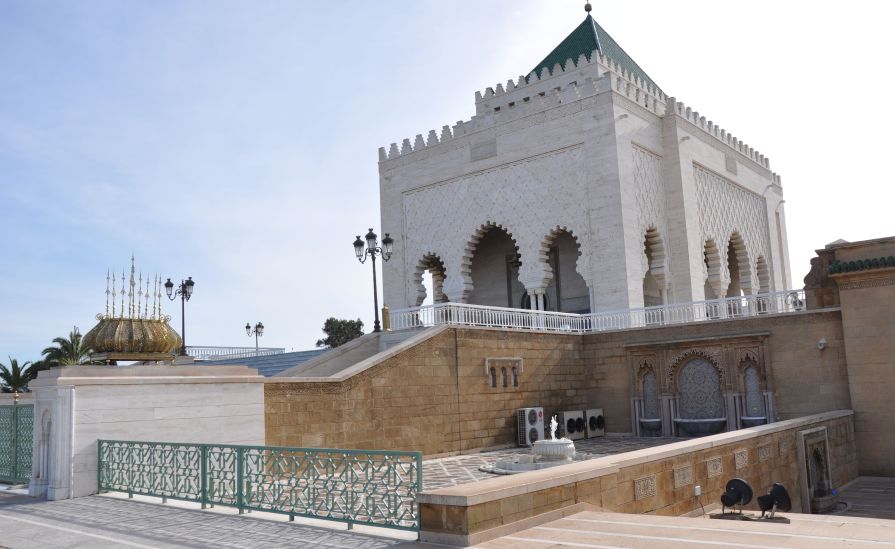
[418,410,854,507]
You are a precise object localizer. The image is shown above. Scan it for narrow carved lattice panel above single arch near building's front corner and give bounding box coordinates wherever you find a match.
[632,145,668,276]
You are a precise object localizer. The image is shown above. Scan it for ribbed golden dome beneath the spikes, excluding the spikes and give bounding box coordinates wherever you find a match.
[83,318,182,354]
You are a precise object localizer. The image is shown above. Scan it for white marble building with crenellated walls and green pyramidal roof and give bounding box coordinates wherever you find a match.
[379,14,790,312]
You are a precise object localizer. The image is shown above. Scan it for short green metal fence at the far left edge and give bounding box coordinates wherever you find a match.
[0,404,34,484]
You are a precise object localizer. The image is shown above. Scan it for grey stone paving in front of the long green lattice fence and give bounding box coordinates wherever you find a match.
[0,492,431,549]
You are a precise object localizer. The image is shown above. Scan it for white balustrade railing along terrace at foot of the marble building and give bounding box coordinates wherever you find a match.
[389,290,805,333]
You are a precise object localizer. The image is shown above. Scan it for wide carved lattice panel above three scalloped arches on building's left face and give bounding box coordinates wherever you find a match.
[403,147,594,301]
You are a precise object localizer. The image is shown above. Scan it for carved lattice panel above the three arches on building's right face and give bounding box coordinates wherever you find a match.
[693,165,770,291]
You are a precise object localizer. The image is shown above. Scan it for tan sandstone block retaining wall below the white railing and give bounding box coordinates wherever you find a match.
[265,311,850,455]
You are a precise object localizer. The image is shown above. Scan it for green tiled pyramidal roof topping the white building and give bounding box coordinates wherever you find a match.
[529,14,662,91]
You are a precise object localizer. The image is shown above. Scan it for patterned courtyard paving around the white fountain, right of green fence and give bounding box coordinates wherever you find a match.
[423,436,688,490]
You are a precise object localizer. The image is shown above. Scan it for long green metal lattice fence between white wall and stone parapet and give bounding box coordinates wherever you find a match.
[98,440,423,531]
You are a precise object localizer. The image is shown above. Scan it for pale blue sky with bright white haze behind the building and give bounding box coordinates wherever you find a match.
[0,0,895,363]
